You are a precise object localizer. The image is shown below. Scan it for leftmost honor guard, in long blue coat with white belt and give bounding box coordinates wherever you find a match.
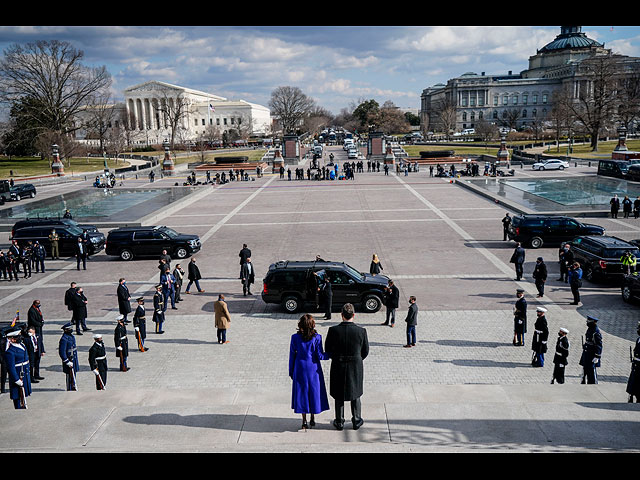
[2,328,31,410]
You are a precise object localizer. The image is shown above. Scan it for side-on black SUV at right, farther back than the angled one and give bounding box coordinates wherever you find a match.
[508,215,605,248]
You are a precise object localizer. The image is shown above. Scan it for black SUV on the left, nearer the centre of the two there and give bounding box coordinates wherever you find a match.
[105,226,202,260]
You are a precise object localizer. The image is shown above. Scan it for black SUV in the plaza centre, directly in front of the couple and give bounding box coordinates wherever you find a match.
[262,261,389,313]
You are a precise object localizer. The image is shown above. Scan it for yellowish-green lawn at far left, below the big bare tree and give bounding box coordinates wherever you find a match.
[0,156,129,179]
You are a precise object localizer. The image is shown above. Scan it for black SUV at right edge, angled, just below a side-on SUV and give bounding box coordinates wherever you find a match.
[571,236,640,282]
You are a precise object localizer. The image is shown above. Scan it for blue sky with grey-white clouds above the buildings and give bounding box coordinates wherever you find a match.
[0,25,640,113]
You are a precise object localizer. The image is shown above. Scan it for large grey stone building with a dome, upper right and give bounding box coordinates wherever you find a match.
[420,26,640,132]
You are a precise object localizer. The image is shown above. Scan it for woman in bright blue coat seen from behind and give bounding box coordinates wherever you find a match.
[289,314,329,428]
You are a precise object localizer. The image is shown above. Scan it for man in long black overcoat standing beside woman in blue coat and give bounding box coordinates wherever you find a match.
[324,303,369,430]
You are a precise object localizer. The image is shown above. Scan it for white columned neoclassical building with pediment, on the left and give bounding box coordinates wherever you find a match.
[76,81,271,145]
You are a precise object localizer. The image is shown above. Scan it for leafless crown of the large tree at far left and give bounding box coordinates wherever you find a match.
[0,40,111,139]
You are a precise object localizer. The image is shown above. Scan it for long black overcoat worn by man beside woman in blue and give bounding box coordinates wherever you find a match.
[324,322,369,401]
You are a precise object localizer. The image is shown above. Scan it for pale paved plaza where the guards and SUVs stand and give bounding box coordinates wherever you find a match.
[0,147,640,452]
